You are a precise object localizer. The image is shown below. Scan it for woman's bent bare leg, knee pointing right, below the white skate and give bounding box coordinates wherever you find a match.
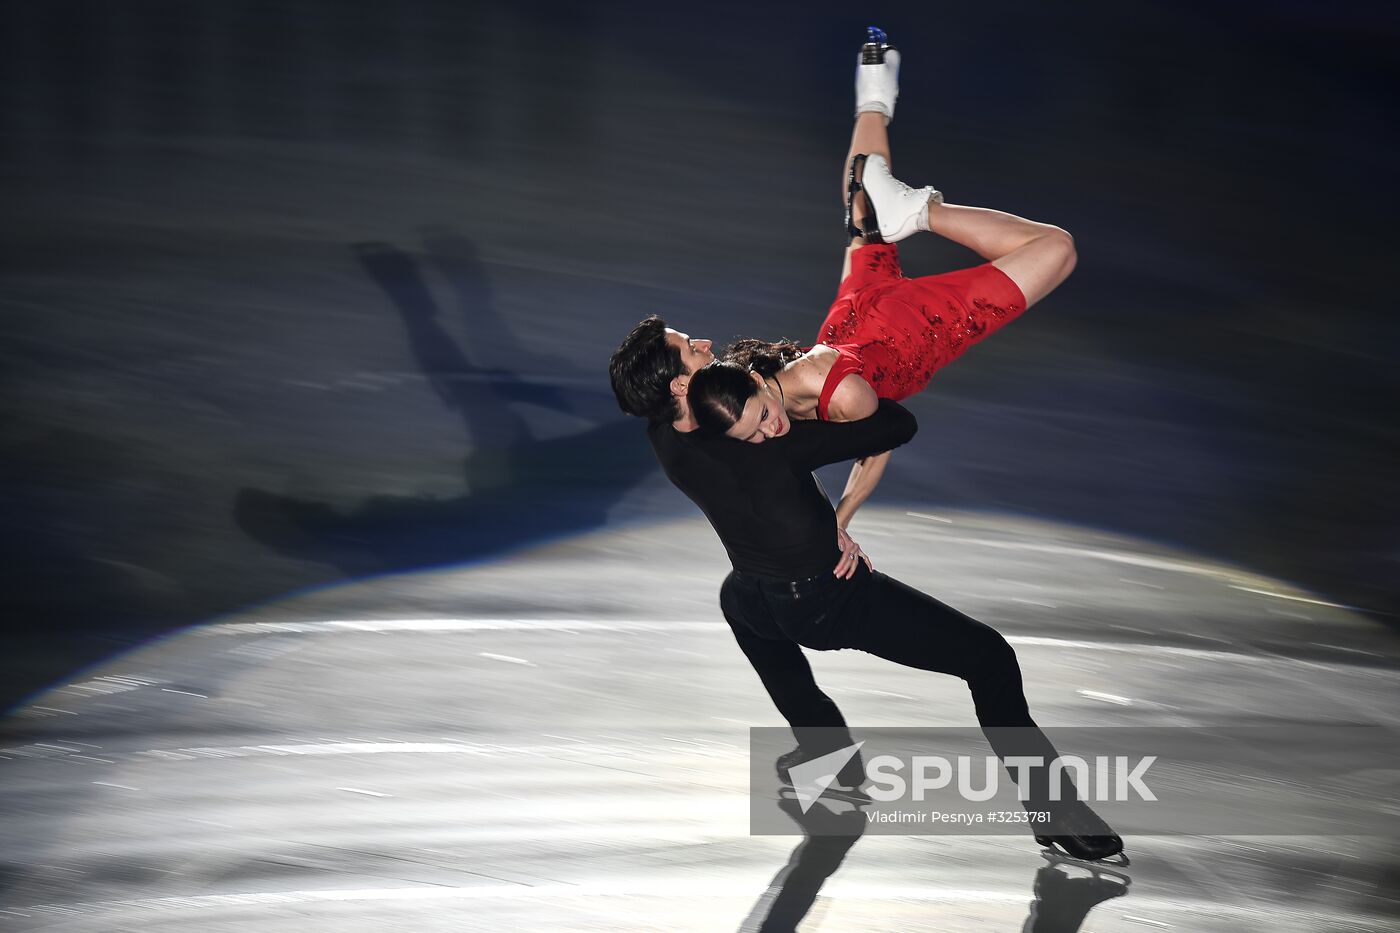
[928,205,1077,308]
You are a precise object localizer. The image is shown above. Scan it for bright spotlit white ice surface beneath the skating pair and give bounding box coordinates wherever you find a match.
[0,509,1400,933]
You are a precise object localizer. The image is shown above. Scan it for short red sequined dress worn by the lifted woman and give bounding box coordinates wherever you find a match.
[816,244,1026,420]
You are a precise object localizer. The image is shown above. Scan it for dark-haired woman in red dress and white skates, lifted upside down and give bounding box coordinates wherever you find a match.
[690,27,1075,530]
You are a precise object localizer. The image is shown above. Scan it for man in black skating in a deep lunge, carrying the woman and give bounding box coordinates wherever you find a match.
[609,315,1123,859]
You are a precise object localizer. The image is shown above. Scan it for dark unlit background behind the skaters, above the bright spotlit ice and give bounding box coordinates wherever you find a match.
[0,0,1400,706]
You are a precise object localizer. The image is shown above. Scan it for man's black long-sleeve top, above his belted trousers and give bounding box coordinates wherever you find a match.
[647,399,918,580]
